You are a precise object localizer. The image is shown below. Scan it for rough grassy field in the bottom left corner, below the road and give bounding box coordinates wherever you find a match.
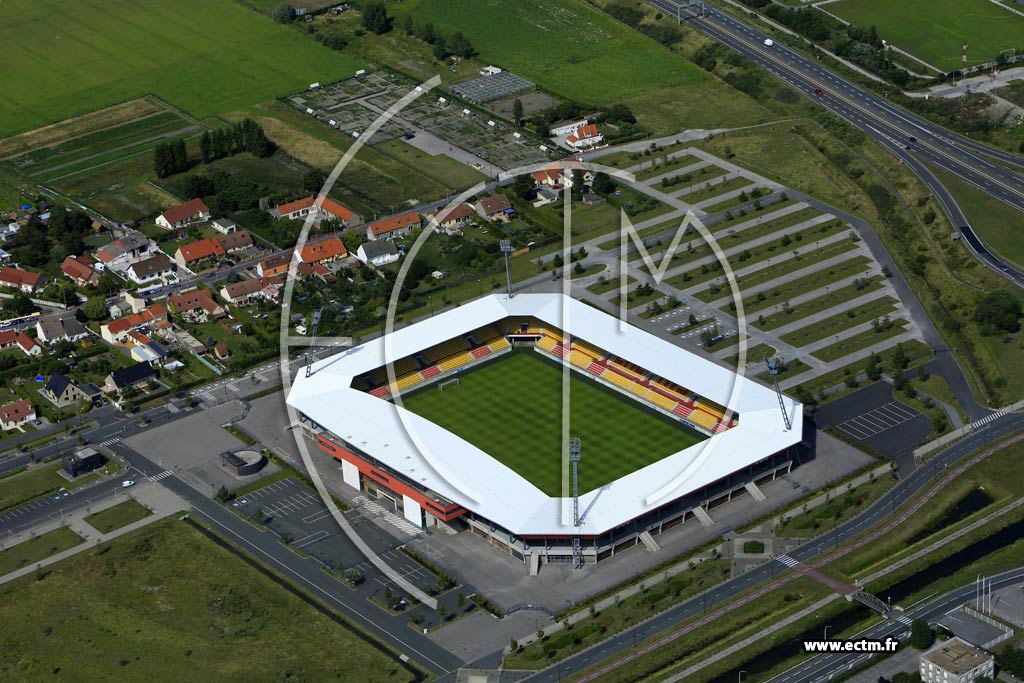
[0,519,414,683]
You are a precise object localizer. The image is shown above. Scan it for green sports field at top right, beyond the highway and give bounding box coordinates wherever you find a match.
[825,0,1024,71]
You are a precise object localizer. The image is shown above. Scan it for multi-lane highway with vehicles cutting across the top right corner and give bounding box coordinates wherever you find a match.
[648,0,1024,286]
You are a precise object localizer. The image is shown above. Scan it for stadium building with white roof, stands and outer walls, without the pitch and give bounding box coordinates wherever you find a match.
[288,294,803,571]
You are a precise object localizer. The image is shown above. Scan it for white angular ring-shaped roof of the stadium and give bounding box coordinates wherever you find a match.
[288,294,803,536]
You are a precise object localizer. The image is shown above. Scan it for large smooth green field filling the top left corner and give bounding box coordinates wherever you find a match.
[0,0,359,136]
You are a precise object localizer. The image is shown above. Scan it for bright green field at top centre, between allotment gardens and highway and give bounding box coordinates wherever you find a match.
[413,0,711,102]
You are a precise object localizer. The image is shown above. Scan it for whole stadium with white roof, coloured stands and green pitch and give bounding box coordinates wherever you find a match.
[288,294,803,573]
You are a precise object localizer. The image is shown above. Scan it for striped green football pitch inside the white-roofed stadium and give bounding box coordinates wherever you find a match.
[403,351,707,496]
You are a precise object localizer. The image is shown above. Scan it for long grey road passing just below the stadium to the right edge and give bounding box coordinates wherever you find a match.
[524,413,1024,683]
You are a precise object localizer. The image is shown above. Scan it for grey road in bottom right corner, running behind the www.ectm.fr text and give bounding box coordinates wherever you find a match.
[771,567,1024,683]
